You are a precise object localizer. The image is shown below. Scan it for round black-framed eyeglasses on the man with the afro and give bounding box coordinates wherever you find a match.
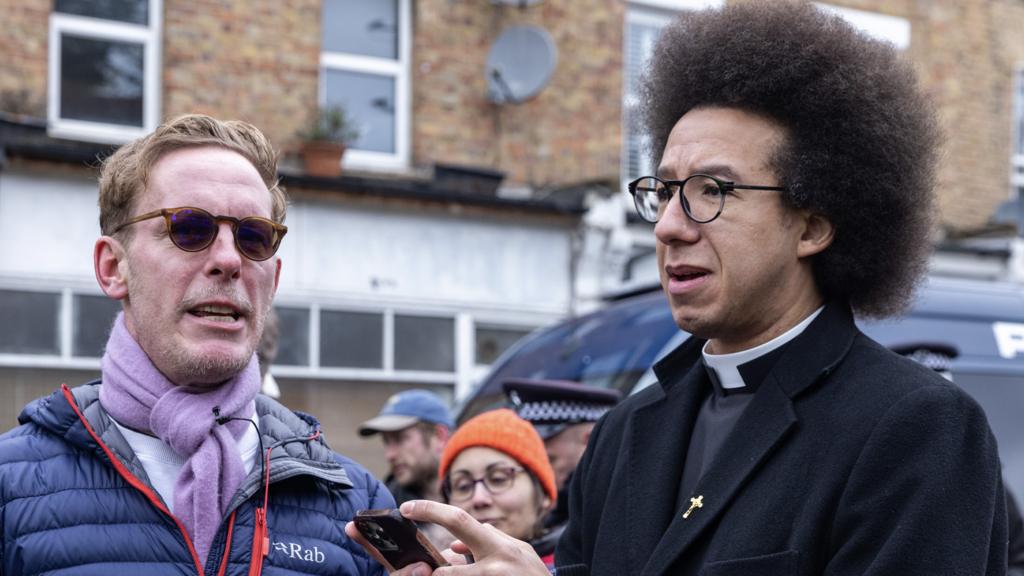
[629,174,786,223]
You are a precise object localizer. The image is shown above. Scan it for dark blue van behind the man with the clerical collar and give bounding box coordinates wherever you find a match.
[459,279,1024,500]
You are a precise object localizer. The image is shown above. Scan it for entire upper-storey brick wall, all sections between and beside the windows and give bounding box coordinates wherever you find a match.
[0,0,1024,234]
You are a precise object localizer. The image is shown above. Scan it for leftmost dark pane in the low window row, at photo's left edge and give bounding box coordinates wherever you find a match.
[0,290,60,355]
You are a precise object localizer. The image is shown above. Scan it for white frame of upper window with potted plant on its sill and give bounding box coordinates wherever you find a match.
[319,0,413,170]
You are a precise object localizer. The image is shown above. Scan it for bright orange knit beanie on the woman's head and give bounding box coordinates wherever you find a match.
[437,408,558,502]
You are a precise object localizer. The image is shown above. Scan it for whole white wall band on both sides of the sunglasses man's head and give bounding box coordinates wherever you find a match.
[0,171,571,316]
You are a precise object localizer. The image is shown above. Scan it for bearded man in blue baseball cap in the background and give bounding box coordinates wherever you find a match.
[359,389,455,504]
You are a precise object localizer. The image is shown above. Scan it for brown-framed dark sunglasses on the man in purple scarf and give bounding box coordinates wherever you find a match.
[111,206,288,261]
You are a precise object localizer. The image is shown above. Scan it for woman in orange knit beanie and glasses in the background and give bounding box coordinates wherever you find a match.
[438,409,557,567]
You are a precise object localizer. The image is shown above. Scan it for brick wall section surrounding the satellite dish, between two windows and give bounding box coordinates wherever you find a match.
[413,0,625,187]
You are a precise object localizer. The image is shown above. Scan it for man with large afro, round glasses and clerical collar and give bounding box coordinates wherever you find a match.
[352,2,1007,576]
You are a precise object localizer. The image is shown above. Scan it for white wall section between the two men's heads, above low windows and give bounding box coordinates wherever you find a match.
[281,202,571,315]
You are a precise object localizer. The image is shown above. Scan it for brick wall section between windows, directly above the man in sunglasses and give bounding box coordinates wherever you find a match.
[163,0,321,151]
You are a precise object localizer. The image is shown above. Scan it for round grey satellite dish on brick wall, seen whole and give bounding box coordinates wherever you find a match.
[486,26,558,104]
